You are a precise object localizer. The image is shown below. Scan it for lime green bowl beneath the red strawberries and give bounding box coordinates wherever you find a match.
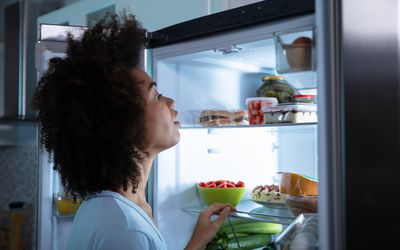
[197,186,245,207]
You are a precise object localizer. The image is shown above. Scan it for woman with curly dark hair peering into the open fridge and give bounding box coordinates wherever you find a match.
[31,13,234,250]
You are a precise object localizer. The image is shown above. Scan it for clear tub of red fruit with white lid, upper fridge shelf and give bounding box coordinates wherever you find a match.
[246,97,278,124]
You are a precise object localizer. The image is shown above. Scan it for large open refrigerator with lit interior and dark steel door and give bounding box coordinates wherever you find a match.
[36,0,400,249]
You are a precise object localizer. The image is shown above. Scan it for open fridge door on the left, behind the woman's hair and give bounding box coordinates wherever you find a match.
[35,24,86,249]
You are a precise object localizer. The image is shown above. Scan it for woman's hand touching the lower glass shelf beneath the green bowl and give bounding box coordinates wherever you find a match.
[185,203,236,250]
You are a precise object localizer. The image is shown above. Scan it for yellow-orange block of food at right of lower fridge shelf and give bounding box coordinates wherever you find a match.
[280,172,318,196]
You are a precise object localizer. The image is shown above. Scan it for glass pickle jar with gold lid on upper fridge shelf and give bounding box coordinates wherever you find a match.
[256,76,300,103]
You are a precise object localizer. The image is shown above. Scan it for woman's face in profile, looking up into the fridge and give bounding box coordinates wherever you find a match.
[132,68,180,154]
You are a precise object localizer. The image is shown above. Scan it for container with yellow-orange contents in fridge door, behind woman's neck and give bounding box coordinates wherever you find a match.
[53,193,82,216]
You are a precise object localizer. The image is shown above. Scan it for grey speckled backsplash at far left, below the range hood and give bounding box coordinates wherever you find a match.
[0,145,38,249]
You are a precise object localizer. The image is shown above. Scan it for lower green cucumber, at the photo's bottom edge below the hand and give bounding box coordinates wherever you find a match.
[227,234,271,250]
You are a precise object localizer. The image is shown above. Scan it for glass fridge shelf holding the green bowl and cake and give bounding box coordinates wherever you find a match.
[183,199,296,225]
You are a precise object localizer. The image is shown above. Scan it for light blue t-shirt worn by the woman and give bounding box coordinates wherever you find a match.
[66,191,167,250]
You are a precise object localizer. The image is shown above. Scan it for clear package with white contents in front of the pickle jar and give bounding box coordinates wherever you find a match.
[263,103,318,123]
